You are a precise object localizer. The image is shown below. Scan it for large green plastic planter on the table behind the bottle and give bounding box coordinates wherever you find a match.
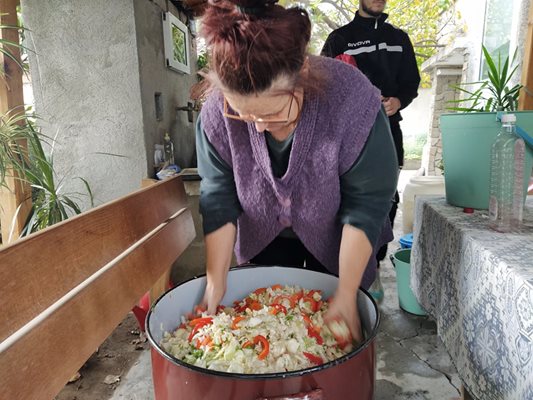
[440,111,533,210]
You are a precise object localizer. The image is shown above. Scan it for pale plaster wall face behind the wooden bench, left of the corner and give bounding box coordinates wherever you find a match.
[22,0,147,207]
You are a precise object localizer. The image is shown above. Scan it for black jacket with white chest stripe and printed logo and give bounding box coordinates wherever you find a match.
[322,13,420,122]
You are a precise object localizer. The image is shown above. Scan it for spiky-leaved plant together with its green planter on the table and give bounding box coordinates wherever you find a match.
[440,47,533,209]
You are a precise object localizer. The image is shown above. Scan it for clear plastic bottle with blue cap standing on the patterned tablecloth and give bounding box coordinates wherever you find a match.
[489,114,525,232]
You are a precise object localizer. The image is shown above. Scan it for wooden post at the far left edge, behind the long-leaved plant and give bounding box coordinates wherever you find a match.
[0,0,31,244]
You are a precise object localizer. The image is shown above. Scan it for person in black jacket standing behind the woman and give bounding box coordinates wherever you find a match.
[321,0,420,300]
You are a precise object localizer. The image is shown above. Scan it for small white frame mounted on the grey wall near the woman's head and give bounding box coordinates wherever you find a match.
[163,12,191,74]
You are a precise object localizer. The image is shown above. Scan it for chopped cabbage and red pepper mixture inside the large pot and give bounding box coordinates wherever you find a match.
[161,285,353,374]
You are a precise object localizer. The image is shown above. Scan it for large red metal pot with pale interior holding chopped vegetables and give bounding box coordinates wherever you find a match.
[146,266,379,400]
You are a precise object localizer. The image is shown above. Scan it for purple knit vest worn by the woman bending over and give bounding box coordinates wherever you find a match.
[201,57,392,287]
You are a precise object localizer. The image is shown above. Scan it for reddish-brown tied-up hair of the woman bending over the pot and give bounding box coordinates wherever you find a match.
[194,0,311,95]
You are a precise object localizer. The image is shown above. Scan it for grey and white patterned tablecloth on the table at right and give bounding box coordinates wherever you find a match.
[411,197,533,400]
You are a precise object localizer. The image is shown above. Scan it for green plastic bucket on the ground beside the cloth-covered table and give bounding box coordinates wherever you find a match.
[391,249,427,315]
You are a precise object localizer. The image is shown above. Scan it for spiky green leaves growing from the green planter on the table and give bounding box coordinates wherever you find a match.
[448,46,523,112]
